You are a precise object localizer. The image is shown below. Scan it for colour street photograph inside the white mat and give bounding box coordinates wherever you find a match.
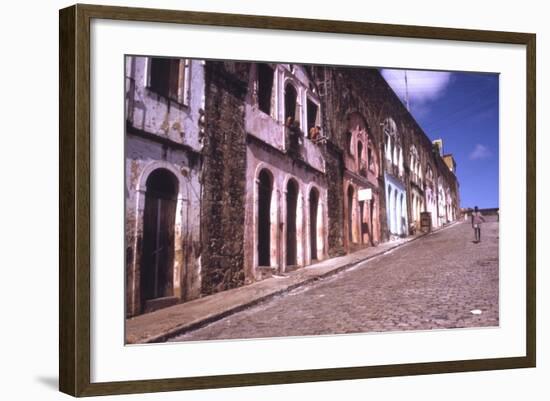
[123,55,499,344]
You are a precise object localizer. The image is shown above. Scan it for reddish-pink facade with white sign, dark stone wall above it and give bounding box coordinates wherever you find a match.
[312,66,387,247]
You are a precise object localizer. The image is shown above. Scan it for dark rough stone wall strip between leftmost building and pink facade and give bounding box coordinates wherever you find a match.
[201,61,247,295]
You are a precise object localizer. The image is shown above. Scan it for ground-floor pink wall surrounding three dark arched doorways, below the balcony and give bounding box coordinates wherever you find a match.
[245,139,328,281]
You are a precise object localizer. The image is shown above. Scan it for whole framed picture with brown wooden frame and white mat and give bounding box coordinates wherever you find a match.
[60,5,536,396]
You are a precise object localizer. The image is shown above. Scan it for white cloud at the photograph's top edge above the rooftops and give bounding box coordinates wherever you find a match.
[380,69,452,103]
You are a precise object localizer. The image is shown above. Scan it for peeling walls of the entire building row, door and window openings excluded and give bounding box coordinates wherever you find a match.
[126,57,459,313]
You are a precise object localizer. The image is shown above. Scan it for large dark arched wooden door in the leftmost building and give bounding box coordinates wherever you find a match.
[140,168,178,310]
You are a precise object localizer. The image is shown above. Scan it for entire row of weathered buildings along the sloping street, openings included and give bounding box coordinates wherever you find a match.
[126,57,459,316]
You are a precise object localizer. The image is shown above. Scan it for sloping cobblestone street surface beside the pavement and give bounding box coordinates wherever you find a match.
[171,221,499,341]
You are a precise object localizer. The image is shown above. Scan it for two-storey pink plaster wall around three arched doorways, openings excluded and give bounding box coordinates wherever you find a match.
[244,63,328,282]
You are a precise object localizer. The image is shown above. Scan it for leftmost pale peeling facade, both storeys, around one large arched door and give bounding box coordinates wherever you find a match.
[125,57,204,316]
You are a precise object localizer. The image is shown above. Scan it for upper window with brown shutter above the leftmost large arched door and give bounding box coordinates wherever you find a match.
[148,57,189,104]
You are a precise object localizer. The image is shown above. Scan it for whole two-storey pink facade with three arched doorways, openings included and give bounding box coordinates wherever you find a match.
[244,63,328,282]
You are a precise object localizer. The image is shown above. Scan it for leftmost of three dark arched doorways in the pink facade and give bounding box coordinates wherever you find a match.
[258,170,273,266]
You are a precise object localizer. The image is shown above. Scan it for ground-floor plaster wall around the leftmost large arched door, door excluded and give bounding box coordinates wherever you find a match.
[126,137,201,315]
